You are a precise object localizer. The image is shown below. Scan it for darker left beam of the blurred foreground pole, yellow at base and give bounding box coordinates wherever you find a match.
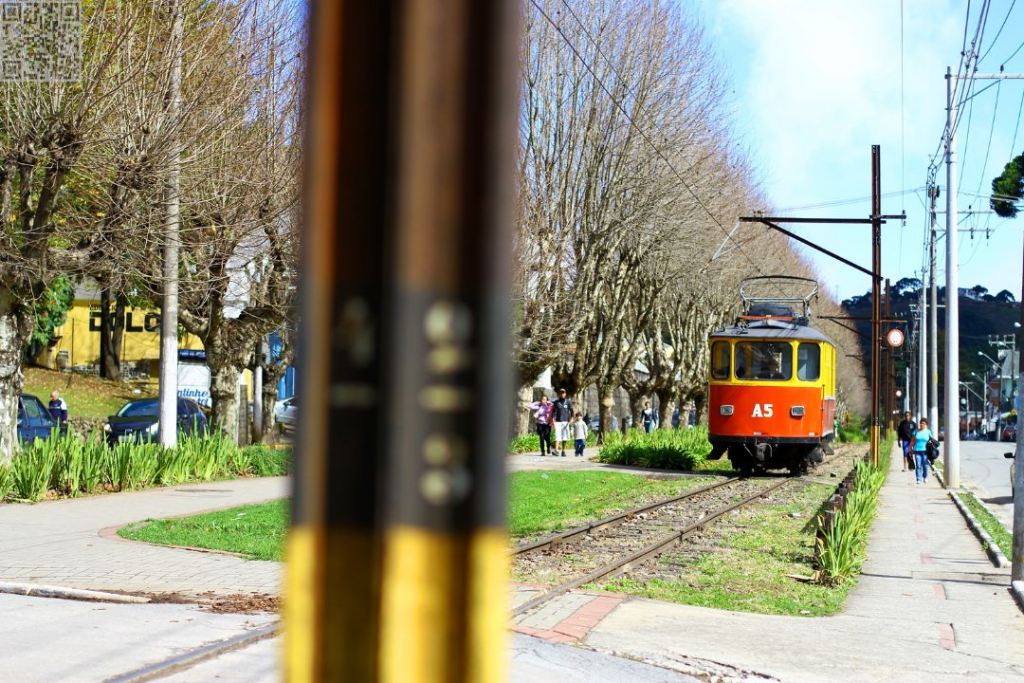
[283,1,393,683]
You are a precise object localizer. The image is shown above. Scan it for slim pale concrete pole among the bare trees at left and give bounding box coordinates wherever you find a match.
[160,0,184,449]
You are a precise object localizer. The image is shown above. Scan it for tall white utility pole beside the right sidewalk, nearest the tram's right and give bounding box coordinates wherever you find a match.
[942,68,959,489]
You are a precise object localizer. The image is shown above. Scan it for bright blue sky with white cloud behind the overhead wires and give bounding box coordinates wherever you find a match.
[700,0,1024,299]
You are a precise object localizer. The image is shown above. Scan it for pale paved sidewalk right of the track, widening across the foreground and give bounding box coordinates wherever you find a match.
[516,448,1024,683]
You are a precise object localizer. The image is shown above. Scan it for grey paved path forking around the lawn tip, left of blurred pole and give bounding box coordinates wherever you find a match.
[0,477,289,594]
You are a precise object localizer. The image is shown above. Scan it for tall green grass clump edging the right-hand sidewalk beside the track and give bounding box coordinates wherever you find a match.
[817,439,892,586]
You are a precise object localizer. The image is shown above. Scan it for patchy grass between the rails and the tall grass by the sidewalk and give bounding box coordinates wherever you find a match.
[604,484,853,616]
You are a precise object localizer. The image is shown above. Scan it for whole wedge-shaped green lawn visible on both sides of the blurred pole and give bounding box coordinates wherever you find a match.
[118,471,710,560]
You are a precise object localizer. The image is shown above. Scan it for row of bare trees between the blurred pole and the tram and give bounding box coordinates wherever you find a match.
[515,0,864,431]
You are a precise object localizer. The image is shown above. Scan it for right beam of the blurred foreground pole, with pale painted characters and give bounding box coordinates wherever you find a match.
[378,0,520,683]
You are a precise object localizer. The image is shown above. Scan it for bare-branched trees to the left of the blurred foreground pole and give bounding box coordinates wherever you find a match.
[0,0,302,457]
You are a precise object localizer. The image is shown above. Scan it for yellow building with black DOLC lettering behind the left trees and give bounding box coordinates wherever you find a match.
[37,285,203,377]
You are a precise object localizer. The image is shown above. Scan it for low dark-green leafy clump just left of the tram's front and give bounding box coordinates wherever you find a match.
[598,427,711,470]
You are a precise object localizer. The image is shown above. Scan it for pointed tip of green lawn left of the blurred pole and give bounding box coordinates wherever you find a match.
[118,501,289,560]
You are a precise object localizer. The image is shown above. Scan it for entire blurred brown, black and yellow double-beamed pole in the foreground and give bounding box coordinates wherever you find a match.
[285,0,518,683]
